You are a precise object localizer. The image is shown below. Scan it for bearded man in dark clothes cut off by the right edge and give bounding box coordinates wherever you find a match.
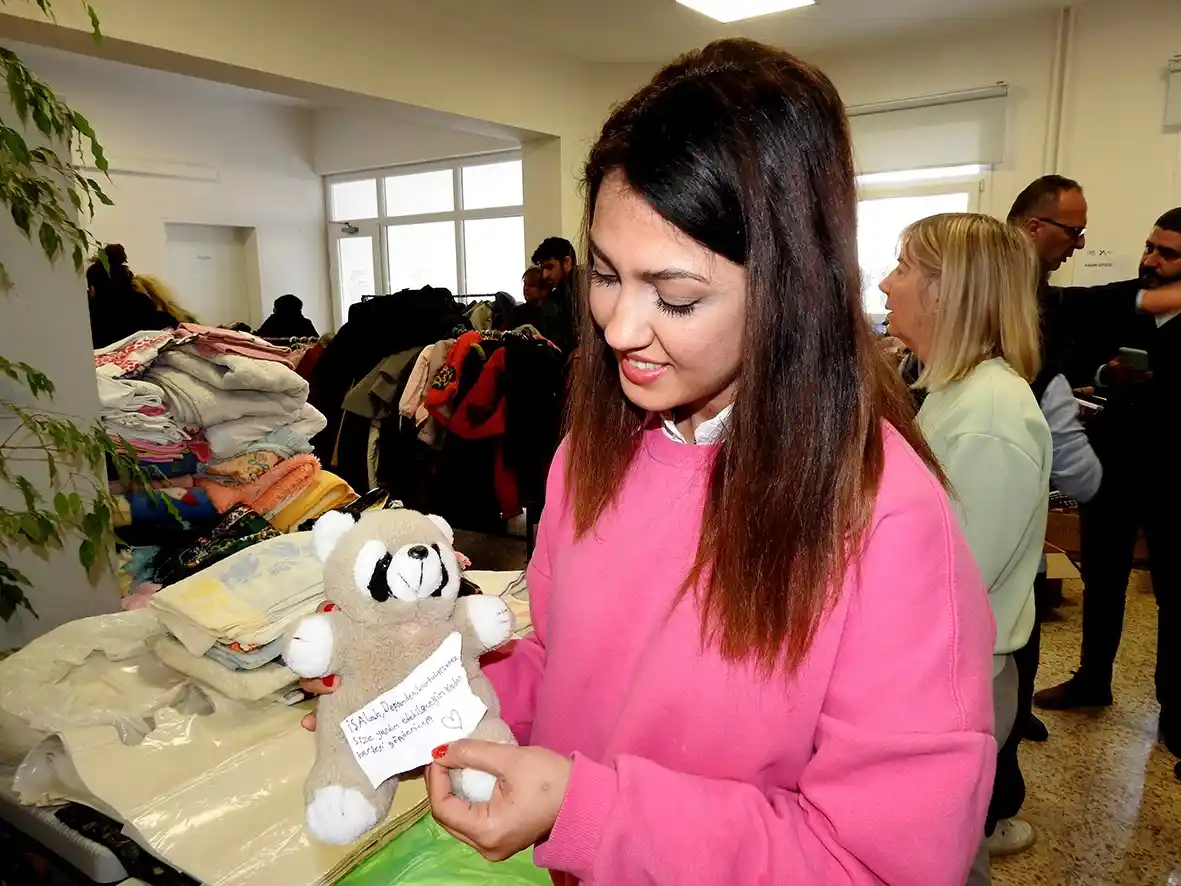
[1035,207,1181,777]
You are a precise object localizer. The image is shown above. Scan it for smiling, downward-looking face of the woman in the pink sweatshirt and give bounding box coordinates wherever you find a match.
[589,172,746,419]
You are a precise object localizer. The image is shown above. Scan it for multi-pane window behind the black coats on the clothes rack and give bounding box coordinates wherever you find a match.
[327,155,526,319]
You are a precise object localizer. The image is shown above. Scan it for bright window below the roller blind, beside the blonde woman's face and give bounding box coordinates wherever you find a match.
[857,167,988,324]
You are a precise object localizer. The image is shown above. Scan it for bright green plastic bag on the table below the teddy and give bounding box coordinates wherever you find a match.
[337,815,552,886]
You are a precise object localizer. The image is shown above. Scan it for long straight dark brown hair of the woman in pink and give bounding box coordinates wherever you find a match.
[567,40,942,672]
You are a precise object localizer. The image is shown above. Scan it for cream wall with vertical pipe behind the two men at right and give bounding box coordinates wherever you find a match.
[811,0,1181,281]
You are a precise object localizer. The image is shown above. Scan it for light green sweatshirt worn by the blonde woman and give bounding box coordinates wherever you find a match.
[919,358,1053,677]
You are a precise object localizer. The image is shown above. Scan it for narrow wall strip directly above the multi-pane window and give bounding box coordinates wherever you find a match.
[312,109,520,175]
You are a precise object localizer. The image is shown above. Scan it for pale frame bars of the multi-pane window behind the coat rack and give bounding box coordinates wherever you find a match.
[324,150,528,326]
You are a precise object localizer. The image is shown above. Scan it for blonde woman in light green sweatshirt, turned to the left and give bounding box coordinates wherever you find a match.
[881,214,1053,884]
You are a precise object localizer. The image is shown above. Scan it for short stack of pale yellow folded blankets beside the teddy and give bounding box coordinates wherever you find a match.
[149,533,324,695]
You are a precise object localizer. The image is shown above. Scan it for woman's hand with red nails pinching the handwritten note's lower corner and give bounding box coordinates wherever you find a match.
[426,741,574,861]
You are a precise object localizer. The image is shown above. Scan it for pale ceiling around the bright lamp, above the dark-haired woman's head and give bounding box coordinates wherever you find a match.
[415,0,1070,63]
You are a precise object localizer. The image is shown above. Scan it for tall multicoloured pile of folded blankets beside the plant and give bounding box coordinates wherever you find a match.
[94,324,337,606]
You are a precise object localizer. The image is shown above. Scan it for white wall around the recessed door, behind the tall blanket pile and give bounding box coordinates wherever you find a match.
[15,46,332,328]
